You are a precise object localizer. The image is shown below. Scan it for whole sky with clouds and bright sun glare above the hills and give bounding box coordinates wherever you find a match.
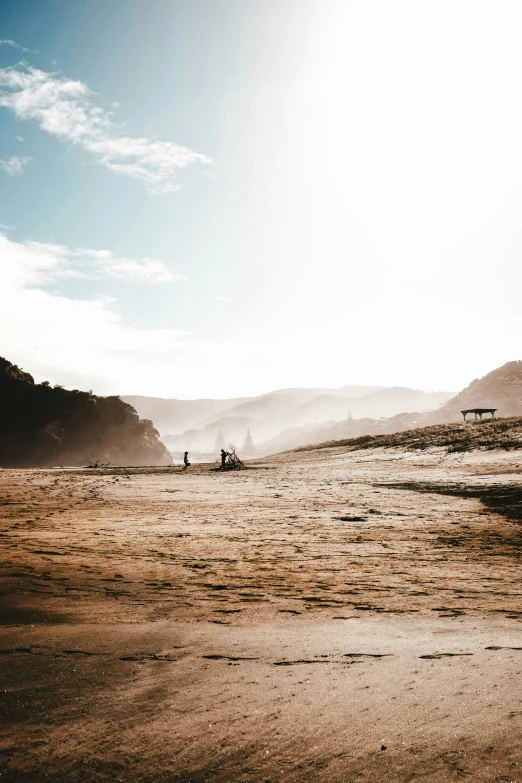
[0,0,522,398]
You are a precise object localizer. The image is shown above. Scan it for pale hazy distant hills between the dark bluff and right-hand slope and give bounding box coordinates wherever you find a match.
[122,385,454,453]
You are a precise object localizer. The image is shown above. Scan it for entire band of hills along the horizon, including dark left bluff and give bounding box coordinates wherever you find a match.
[0,358,522,467]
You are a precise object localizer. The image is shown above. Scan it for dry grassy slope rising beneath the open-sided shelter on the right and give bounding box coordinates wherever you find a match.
[295,416,522,452]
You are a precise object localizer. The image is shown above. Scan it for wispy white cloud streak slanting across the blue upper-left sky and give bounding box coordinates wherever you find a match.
[0,64,209,194]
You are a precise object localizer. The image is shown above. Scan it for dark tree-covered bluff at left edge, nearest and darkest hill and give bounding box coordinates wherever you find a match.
[0,358,172,468]
